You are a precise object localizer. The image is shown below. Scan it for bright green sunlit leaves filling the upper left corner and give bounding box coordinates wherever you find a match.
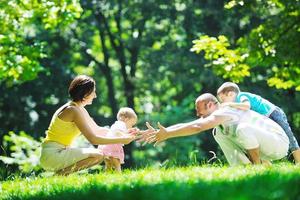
[0,0,82,84]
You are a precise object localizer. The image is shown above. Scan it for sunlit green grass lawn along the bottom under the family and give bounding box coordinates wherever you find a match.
[0,164,300,200]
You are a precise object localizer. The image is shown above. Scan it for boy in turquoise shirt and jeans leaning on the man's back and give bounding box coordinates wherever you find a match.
[217,82,300,163]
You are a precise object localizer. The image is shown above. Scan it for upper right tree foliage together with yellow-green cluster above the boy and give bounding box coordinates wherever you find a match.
[192,0,300,91]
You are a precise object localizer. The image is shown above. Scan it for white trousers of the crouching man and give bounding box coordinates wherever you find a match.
[213,123,289,166]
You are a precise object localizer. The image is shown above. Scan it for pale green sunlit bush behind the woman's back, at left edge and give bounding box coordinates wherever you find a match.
[0,131,41,173]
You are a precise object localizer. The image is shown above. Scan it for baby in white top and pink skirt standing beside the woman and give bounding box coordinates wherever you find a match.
[98,107,137,172]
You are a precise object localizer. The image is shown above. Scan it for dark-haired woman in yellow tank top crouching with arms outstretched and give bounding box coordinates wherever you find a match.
[40,75,134,175]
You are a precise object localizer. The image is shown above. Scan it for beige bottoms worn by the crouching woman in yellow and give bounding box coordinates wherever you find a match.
[40,142,101,171]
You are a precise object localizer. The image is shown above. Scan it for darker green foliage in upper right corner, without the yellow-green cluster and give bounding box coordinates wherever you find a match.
[225,0,300,91]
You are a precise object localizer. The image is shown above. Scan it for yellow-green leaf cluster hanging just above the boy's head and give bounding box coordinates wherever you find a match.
[191,35,250,83]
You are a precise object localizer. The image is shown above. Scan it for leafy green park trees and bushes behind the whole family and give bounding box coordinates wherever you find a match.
[0,0,300,180]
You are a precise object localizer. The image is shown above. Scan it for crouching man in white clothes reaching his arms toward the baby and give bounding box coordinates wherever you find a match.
[148,93,289,166]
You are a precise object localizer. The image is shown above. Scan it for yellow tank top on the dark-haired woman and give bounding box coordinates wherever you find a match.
[44,103,80,146]
